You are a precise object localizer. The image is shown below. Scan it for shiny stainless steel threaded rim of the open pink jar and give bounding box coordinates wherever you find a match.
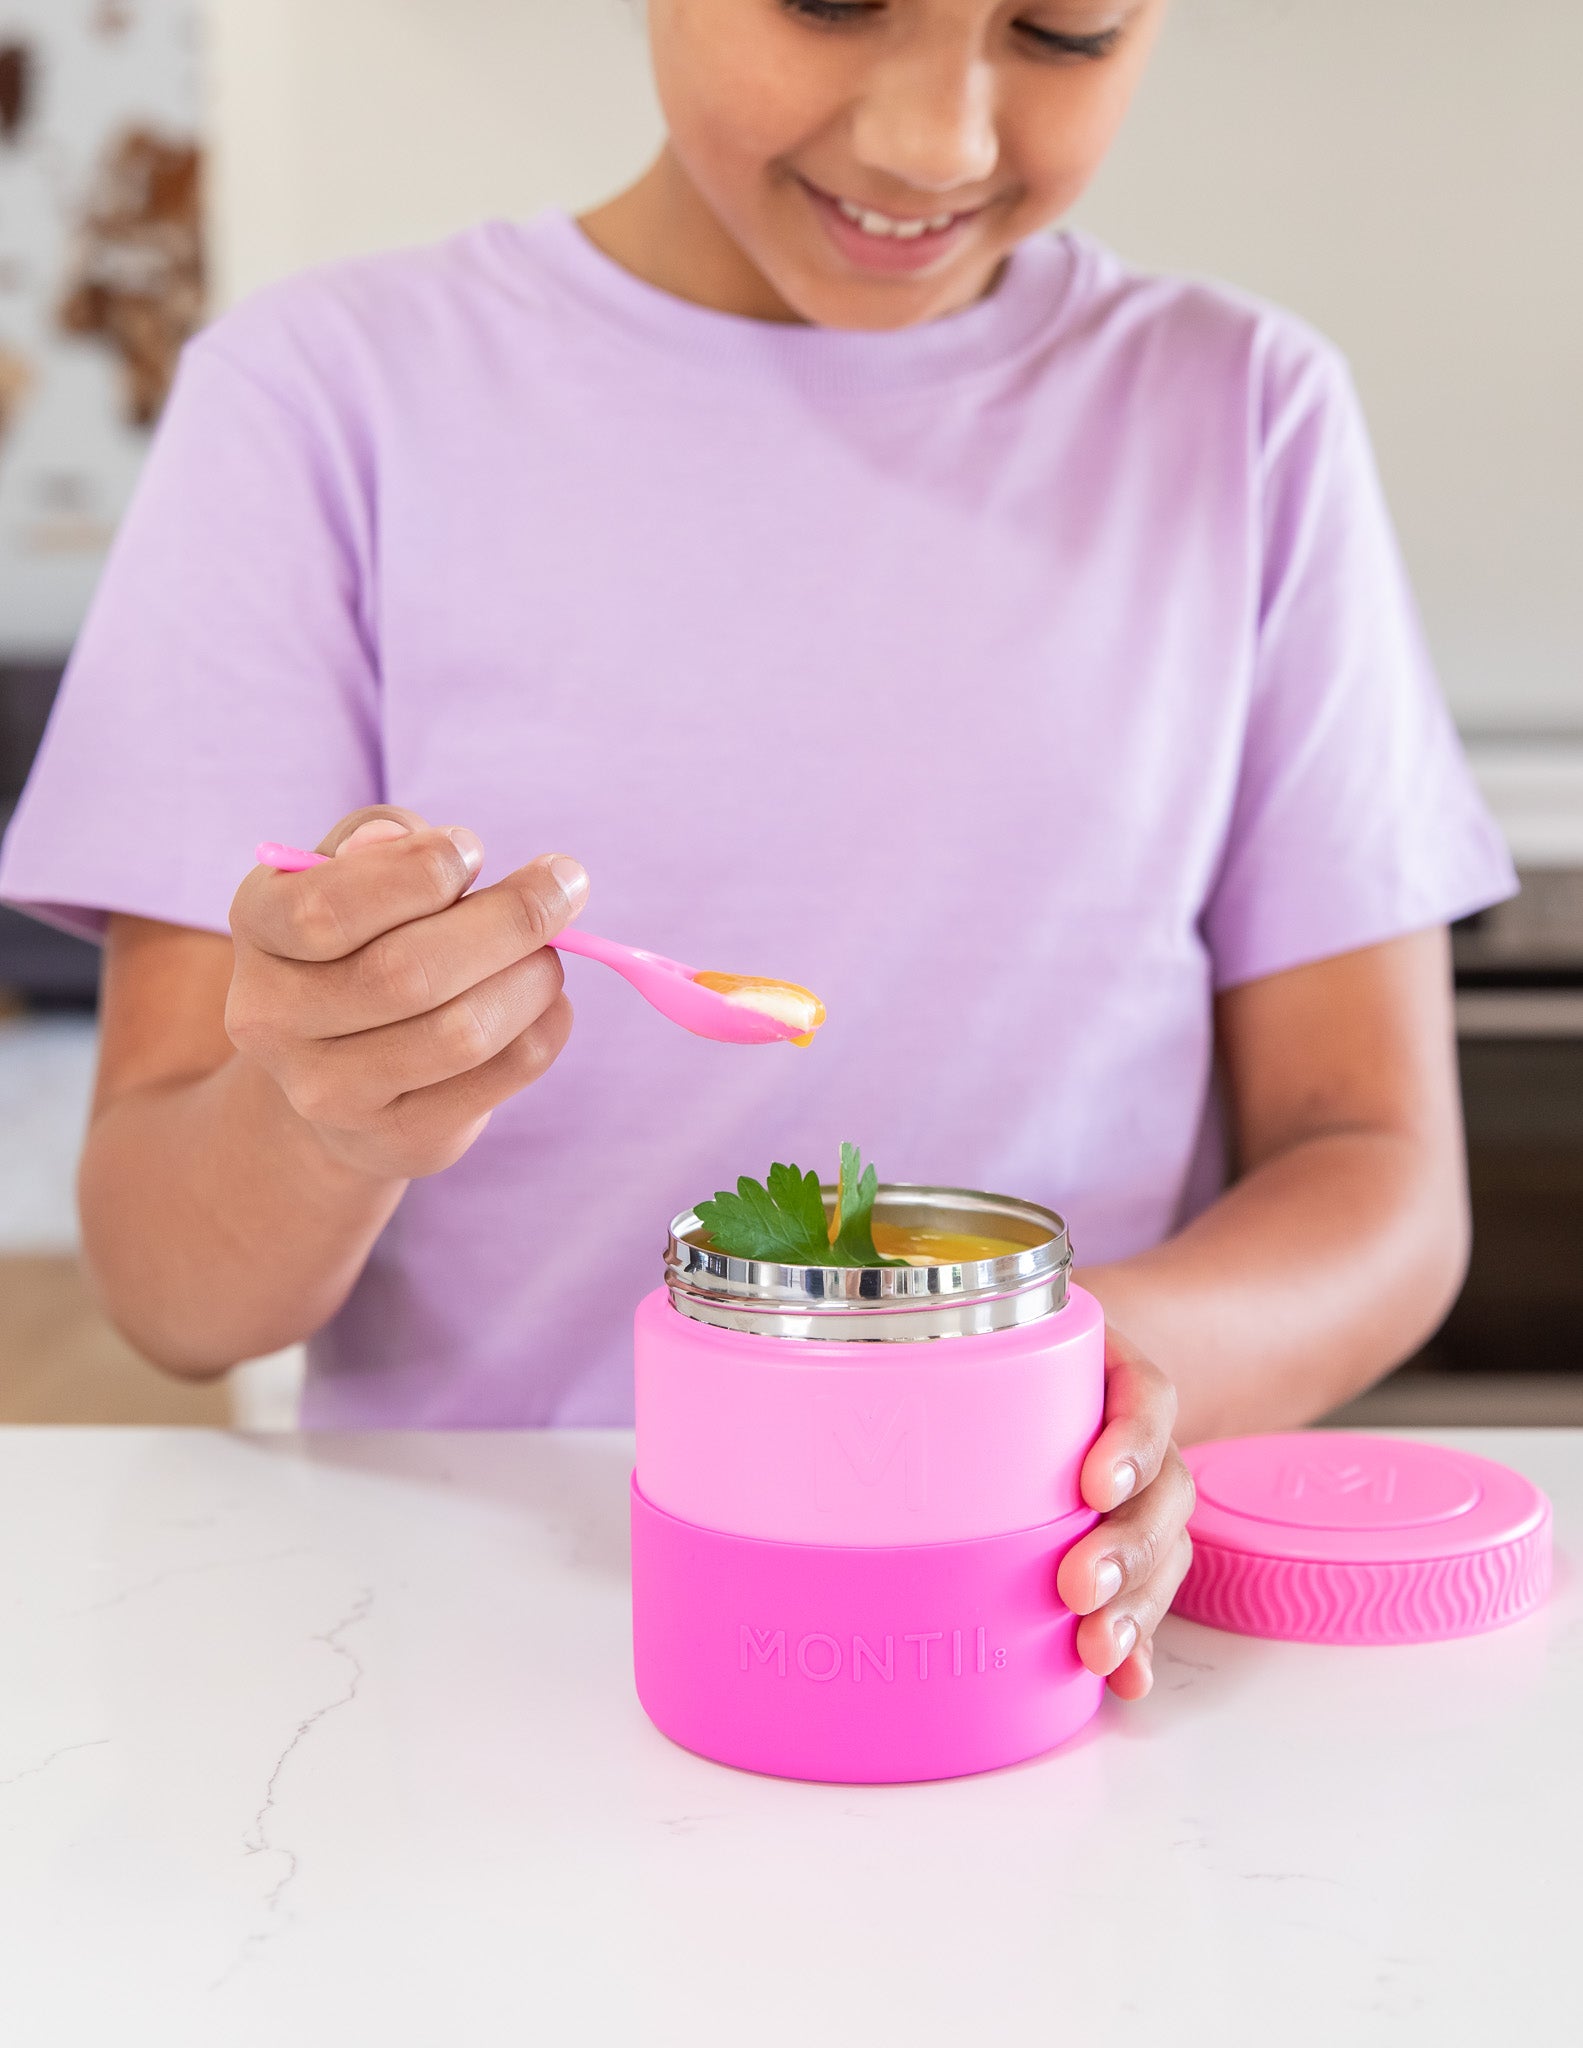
[666,1184,1071,1343]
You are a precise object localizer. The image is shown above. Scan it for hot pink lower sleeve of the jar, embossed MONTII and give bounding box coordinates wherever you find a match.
[633,1481,1104,1784]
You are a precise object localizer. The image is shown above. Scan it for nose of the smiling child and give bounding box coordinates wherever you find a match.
[852,47,999,193]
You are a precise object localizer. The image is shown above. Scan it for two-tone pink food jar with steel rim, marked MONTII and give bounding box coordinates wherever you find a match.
[633,1186,1104,1784]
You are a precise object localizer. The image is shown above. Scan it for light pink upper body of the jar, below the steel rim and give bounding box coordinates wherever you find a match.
[635,1288,1104,1544]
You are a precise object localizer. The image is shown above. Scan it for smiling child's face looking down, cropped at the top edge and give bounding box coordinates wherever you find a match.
[649,0,1165,328]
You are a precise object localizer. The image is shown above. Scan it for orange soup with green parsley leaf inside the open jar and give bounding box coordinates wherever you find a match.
[696,1138,1026,1266]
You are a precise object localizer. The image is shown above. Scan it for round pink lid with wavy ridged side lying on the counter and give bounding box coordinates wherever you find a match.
[1175,1430,1550,1642]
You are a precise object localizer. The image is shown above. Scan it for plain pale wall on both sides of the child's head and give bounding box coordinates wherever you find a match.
[209,0,1583,731]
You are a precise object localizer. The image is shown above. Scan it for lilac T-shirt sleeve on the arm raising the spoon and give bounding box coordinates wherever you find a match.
[0,336,381,938]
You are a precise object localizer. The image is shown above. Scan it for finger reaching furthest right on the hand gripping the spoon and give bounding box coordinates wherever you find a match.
[279,851,588,1040]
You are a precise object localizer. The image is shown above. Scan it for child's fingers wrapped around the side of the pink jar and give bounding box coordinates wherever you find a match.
[1057,1329,1194,1700]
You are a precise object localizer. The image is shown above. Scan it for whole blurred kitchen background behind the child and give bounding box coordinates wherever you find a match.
[0,0,1583,1427]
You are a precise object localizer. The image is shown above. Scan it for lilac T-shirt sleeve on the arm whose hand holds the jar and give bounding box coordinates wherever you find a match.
[1204,340,1515,987]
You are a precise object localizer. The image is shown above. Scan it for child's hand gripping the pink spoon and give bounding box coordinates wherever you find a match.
[225,809,588,1180]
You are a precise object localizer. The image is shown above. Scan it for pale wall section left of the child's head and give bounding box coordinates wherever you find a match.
[207,0,659,301]
